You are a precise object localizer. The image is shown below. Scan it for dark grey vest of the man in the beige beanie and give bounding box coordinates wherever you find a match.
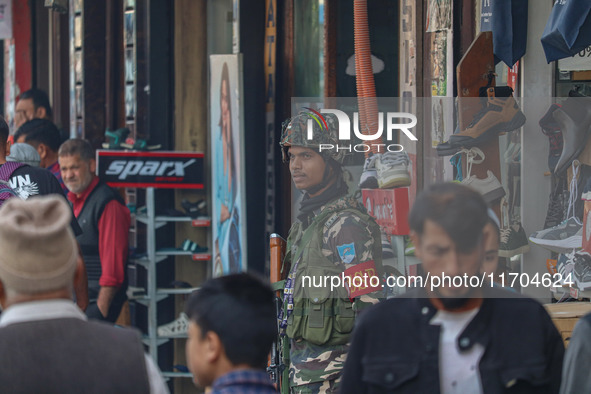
[0,318,150,394]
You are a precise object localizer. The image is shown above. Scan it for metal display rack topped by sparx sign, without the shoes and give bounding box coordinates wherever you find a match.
[97,150,211,378]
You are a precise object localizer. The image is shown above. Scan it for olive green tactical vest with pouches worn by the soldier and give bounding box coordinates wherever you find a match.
[286,197,383,345]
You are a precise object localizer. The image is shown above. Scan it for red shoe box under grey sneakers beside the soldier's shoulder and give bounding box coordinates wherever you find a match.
[361,187,410,235]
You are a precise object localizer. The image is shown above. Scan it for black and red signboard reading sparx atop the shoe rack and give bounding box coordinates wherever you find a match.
[96,150,204,189]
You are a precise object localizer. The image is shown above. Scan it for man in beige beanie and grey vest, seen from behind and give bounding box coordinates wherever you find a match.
[0,196,168,393]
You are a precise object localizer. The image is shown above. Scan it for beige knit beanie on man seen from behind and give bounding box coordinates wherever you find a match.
[0,195,78,294]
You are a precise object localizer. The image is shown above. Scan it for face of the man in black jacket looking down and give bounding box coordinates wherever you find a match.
[411,219,487,298]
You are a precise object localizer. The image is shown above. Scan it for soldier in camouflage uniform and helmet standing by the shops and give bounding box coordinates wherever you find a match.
[279,114,382,393]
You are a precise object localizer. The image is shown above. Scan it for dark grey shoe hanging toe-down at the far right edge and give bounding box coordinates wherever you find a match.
[552,93,591,174]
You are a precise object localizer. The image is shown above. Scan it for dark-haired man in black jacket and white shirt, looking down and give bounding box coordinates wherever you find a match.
[341,183,564,393]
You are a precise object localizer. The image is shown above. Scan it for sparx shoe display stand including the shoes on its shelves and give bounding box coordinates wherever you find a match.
[97,150,212,378]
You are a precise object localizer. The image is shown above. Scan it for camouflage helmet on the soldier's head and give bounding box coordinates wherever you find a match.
[279,112,345,164]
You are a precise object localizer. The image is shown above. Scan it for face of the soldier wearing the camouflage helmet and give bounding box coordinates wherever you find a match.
[288,146,326,190]
